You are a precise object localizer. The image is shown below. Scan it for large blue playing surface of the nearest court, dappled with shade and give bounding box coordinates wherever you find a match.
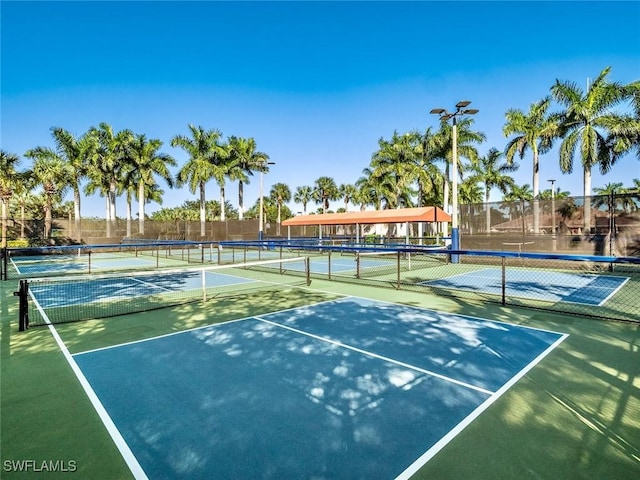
[73,297,565,479]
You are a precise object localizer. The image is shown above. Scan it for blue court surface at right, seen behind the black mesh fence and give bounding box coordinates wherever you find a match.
[419,268,629,305]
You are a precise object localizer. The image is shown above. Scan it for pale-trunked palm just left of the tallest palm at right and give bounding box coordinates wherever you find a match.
[502,96,558,233]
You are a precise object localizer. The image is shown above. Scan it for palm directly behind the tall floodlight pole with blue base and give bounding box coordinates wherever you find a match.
[432,117,486,215]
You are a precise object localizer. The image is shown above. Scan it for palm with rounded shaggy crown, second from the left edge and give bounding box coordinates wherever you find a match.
[25,147,70,238]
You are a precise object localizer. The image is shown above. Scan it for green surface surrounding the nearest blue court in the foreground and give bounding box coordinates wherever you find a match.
[0,279,640,480]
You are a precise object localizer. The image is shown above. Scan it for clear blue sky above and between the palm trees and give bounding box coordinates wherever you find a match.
[0,1,640,216]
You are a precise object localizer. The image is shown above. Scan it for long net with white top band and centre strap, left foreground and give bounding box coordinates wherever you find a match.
[19,257,310,330]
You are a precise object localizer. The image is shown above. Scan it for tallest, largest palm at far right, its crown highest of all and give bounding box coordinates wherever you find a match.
[551,67,626,233]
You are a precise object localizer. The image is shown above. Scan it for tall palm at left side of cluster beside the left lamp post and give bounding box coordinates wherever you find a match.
[171,124,228,237]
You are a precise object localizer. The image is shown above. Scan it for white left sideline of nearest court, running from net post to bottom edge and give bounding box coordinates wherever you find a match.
[31,288,149,480]
